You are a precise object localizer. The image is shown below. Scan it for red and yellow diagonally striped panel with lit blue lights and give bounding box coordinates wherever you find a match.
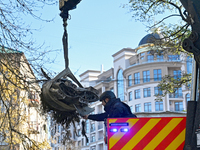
[107,117,186,150]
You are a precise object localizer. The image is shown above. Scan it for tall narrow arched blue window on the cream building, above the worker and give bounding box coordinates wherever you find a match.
[117,69,124,101]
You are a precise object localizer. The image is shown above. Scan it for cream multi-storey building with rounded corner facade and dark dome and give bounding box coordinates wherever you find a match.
[77,33,192,150]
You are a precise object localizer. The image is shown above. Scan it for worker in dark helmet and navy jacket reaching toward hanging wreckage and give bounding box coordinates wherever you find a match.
[83,91,136,121]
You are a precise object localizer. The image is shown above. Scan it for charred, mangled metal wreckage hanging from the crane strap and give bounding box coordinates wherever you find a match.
[42,68,99,116]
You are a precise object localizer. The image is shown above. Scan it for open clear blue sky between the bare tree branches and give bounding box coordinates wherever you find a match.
[32,0,148,80]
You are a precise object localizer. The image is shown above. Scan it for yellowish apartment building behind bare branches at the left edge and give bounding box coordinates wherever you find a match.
[0,47,49,150]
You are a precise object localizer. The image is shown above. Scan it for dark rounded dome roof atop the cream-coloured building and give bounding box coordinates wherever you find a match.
[138,33,164,46]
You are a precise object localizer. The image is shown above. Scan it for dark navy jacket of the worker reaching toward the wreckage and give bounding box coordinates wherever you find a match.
[88,98,136,121]
